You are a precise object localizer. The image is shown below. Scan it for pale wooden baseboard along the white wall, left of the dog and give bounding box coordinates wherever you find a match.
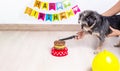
[0,24,80,31]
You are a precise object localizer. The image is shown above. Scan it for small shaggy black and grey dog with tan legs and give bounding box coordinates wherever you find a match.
[78,10,120,54]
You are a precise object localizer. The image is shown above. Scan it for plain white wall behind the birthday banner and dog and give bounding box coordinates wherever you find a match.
[0,0,118,24]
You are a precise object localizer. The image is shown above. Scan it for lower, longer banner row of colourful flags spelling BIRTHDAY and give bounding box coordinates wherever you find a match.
[25,5,80,22]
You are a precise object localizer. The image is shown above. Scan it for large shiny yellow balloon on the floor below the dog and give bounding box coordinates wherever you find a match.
[92,50,119,71]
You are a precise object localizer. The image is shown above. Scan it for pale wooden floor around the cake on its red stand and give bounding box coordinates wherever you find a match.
[0,31,120,71]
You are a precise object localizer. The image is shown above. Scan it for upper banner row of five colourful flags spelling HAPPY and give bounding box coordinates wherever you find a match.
[34,0,71,10]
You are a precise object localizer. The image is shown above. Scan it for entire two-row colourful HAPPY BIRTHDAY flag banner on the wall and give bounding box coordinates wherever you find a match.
[24,0,80,22]
